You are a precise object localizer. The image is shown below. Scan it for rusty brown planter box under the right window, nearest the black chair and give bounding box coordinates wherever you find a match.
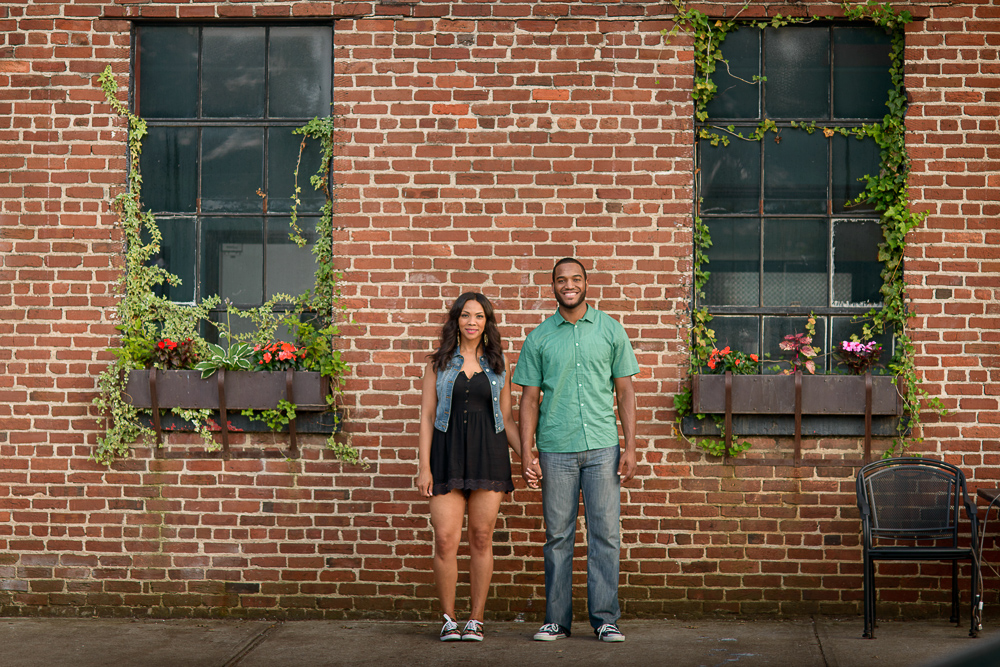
[691,372,903,461]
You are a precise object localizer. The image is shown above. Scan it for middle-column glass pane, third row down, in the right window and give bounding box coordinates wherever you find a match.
[764,220,829,307]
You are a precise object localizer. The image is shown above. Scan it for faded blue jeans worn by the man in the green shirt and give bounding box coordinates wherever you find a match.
[538,443,621,630]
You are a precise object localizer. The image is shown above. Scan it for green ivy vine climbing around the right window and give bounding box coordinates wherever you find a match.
[663,0,944,457]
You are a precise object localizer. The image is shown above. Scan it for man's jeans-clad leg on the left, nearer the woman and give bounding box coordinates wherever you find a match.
[538,452,580,630]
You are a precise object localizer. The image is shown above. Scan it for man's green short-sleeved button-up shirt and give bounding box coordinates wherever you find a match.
[511,306,639,452]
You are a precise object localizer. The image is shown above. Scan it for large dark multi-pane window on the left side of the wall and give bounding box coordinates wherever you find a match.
[134,25,333,335]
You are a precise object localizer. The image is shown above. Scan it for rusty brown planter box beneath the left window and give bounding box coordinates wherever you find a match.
[125,368,330,452]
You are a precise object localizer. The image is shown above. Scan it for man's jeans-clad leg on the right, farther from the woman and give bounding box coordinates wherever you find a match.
[580,444,621,630]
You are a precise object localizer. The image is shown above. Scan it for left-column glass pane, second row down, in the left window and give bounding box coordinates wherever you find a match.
[139,127,198,213]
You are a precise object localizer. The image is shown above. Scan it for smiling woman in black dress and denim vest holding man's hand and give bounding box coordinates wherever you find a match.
[417,292,521,641]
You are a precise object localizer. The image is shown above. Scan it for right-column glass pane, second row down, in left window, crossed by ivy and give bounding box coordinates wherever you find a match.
[267,127,326,215]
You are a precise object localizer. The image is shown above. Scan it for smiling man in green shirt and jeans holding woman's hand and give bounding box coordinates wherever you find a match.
[513,257,639,642]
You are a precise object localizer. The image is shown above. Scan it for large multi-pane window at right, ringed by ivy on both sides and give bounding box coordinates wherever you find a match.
[697,25,891,365]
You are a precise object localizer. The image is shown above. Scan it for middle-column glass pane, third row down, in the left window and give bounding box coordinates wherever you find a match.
[201,218,264,306]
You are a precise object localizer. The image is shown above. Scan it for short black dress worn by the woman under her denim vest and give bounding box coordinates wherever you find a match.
[431,371,514,497]
